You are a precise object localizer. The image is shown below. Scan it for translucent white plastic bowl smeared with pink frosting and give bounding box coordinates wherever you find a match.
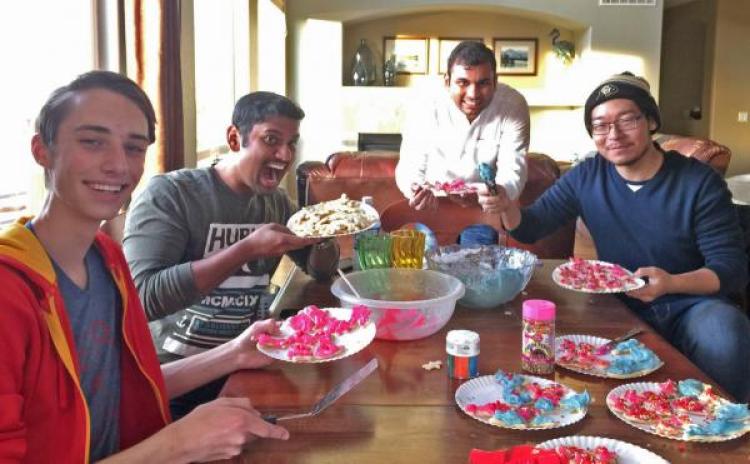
[331,268,464,340]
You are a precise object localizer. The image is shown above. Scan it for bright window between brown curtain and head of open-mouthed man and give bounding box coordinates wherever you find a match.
[194,0,250,166]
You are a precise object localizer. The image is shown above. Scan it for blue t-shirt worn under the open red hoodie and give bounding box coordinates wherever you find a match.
[27,222,122,462]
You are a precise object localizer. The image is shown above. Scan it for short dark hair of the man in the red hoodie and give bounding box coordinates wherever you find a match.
[36,71,156,146]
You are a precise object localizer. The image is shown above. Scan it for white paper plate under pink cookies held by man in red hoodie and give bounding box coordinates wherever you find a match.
[258,308,375,364]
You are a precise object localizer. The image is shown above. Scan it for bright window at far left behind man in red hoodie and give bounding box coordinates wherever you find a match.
[0,0,94,224]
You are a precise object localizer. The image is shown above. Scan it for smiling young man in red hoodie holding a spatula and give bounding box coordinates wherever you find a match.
[0,71,289,463]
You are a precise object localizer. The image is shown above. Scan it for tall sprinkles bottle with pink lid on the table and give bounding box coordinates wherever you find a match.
[521,300,556,374]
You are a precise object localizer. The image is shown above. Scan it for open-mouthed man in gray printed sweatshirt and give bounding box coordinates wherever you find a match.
[123,92,339,417]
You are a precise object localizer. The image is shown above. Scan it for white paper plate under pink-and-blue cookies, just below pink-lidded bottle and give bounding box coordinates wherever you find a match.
[456,374,588,430]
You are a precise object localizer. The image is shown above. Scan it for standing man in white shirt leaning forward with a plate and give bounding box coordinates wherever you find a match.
[396,41,530,216]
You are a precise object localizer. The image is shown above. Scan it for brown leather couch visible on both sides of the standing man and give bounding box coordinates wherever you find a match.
[297,151,575,258]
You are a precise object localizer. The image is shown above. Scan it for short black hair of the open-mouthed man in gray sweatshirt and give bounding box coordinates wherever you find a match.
[232,92,305,146]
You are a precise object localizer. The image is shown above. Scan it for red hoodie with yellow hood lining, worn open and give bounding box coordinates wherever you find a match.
[0,219,170,463]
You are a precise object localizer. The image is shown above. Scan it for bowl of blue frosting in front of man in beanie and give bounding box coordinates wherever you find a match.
[426,245,537,308]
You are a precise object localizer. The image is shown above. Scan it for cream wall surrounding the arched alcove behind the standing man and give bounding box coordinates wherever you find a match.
[286,0,663,169]
